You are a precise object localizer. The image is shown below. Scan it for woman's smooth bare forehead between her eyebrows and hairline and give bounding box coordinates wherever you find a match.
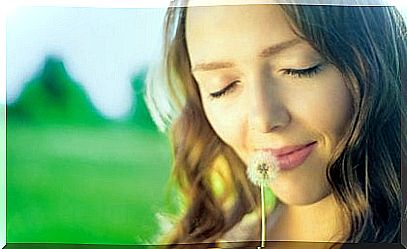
[185,4,298,64]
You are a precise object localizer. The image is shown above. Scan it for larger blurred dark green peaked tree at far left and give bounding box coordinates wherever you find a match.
[7,56,105,125]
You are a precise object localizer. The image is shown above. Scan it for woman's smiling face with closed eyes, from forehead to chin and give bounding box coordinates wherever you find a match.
[186,5,352,205]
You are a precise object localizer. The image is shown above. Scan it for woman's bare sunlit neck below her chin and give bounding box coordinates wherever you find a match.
[268,194,346,242]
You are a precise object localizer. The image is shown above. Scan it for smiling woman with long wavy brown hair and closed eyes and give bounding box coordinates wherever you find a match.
[147,0,407,247]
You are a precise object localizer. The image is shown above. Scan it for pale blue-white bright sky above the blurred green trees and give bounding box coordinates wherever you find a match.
[0,0,407,118]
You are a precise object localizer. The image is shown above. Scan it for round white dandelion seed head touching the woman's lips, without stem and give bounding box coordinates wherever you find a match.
[246,151,279,186]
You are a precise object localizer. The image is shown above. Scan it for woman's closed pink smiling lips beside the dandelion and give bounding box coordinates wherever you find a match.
[262,141,317,170]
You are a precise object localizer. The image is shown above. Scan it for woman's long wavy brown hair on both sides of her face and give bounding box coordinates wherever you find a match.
[147,1,407,244]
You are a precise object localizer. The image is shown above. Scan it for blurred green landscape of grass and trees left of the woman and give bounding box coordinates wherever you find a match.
[6,57,172,244]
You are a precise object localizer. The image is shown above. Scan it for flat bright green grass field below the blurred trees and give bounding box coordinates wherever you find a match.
[6,123,171,244]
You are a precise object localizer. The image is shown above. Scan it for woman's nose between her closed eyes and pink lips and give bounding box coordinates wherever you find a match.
[248,74,291,133]
